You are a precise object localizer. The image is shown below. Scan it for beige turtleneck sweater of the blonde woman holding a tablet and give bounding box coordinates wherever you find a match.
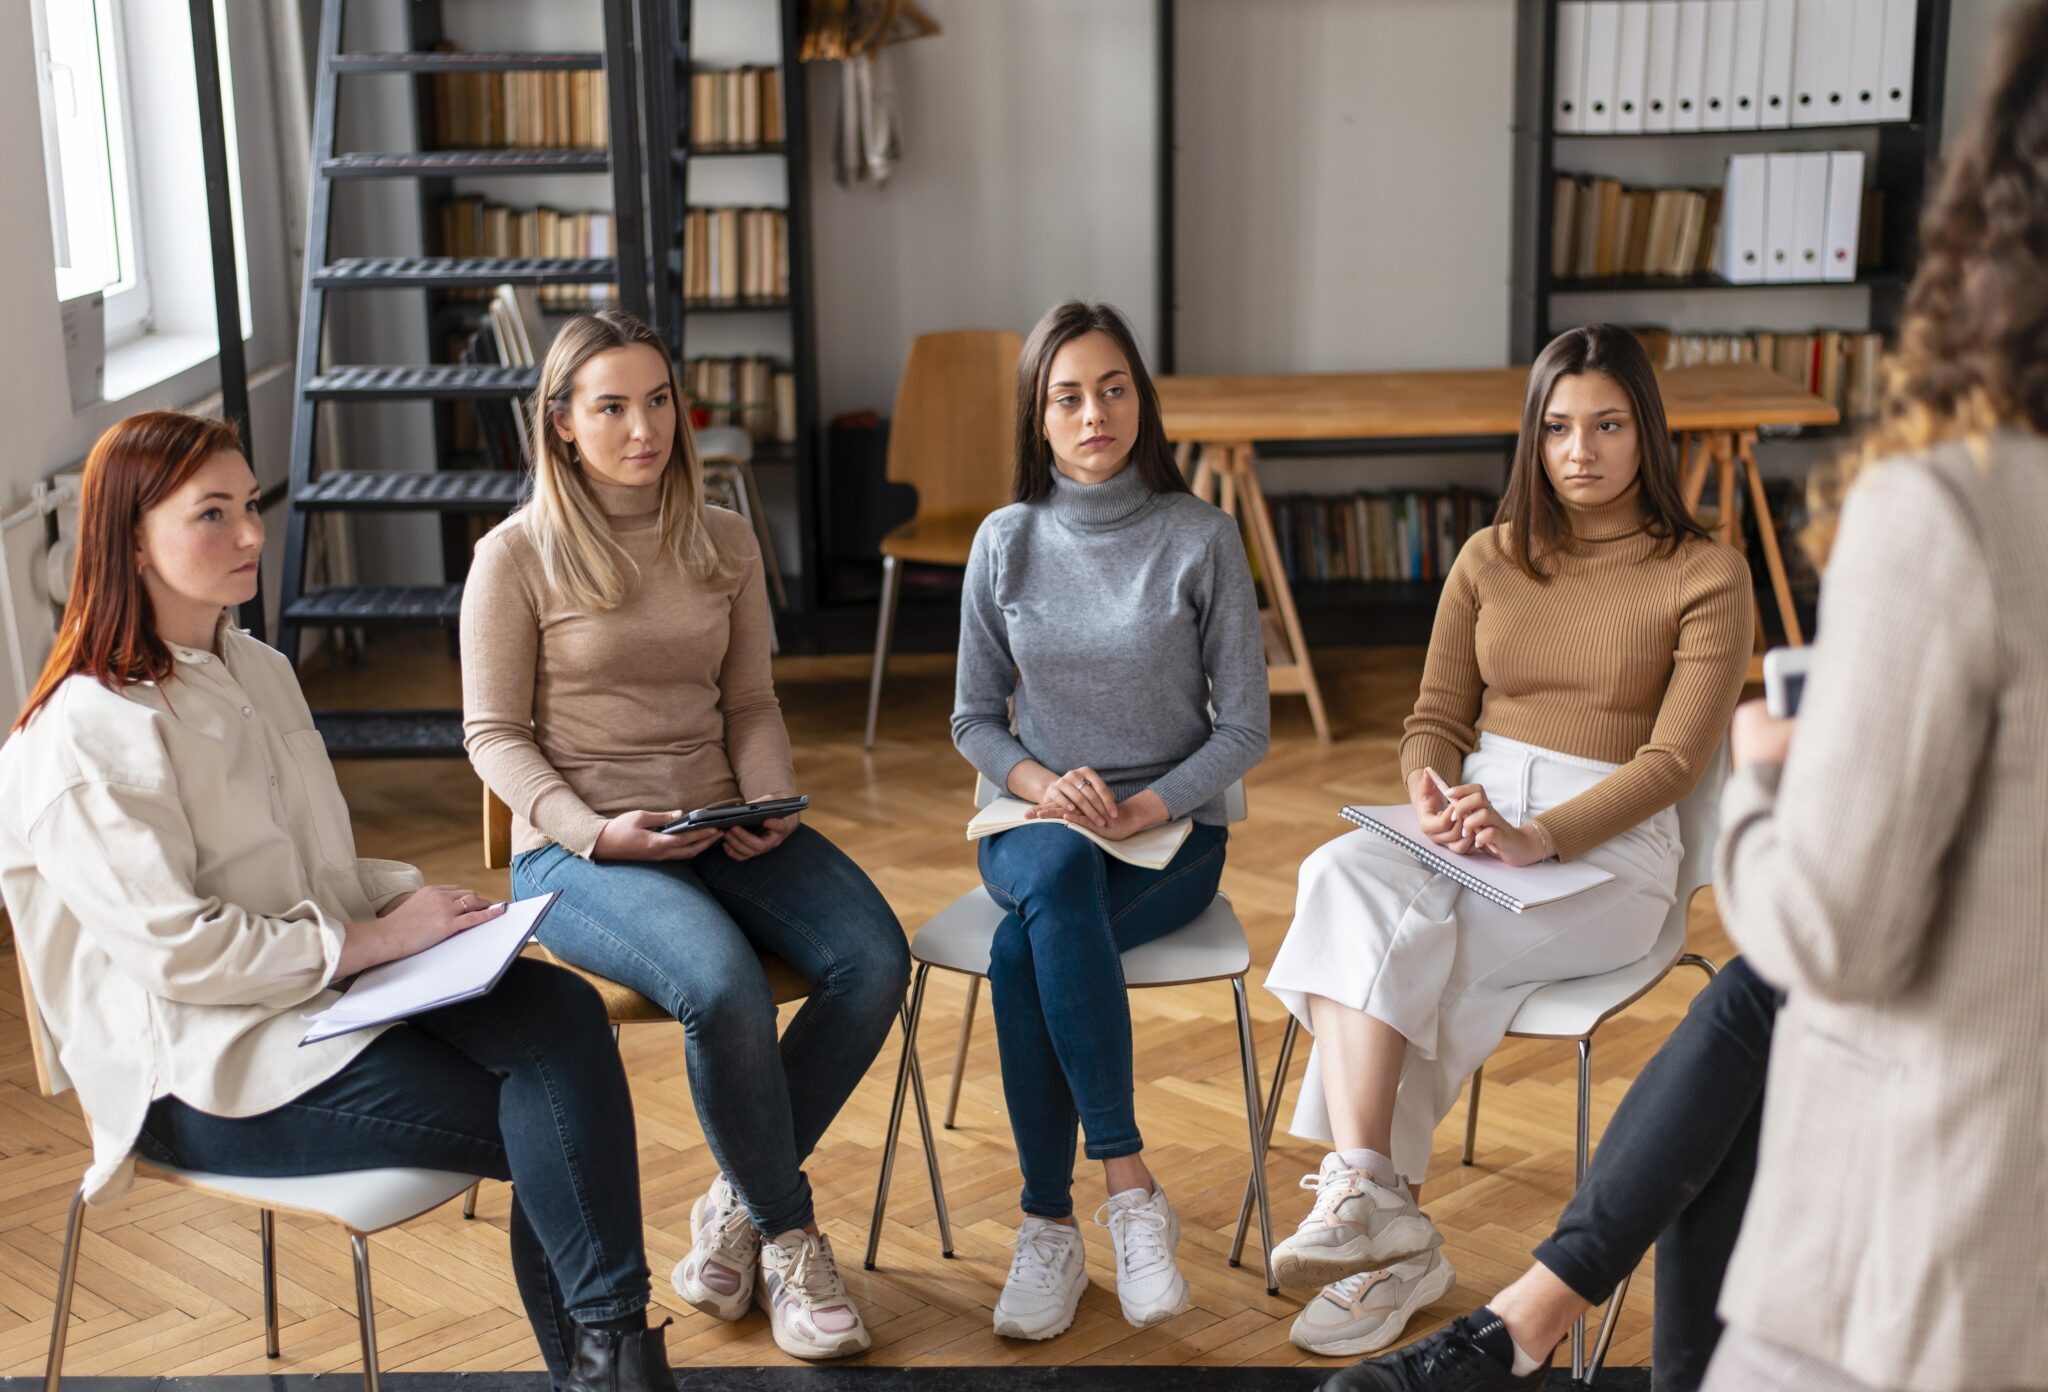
[461,481,797,856]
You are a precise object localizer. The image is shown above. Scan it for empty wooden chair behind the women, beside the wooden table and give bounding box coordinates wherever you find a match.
[866,330,1024,749]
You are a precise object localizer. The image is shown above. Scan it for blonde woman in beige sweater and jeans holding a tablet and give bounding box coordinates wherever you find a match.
[461,311,909,1357]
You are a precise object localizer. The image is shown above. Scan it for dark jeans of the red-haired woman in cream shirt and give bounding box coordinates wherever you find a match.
[137,960,647,1386]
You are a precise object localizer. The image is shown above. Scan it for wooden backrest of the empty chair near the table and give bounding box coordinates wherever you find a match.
[889,330,1024,516]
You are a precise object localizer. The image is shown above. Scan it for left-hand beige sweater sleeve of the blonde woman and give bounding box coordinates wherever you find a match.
[461,522,606,858]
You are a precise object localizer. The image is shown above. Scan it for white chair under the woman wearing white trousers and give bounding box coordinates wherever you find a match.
[1231,745,1729,1386]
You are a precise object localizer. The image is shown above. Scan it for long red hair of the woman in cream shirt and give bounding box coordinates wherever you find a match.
[14,411,242,731]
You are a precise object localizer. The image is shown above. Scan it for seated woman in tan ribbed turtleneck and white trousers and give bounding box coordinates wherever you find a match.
[1266,323,1753,1355]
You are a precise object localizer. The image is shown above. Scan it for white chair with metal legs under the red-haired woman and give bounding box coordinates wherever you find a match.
[14,950,477,1392]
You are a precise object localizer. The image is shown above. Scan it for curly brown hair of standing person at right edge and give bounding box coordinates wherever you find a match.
[1804,0,2048,561]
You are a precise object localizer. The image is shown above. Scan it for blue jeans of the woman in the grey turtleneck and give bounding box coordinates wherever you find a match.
[981,823,1229,1218]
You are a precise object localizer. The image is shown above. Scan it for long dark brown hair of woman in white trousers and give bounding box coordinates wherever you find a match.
[1493,323,1708,579]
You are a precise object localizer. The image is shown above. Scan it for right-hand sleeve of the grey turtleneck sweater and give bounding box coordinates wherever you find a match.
[1151,518,1272,817]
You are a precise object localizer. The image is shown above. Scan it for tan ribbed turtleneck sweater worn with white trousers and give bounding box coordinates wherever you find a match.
[1401,489,1755,860]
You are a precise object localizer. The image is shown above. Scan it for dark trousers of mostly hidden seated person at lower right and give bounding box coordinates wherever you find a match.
[1536,958,1784,1392]
